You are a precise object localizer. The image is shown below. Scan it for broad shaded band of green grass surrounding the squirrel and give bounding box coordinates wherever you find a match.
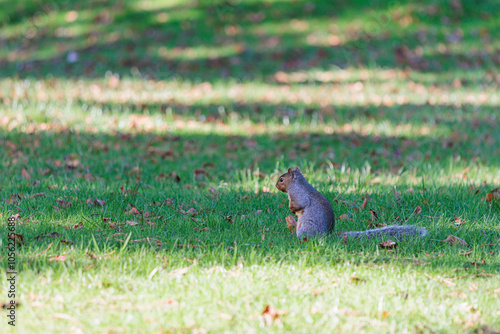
[0,122,499,272]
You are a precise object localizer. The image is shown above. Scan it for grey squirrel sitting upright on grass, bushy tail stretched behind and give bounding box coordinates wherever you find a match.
[276,167,427,239]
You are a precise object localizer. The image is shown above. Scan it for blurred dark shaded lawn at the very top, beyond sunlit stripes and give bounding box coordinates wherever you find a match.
[0,0,500,82]
